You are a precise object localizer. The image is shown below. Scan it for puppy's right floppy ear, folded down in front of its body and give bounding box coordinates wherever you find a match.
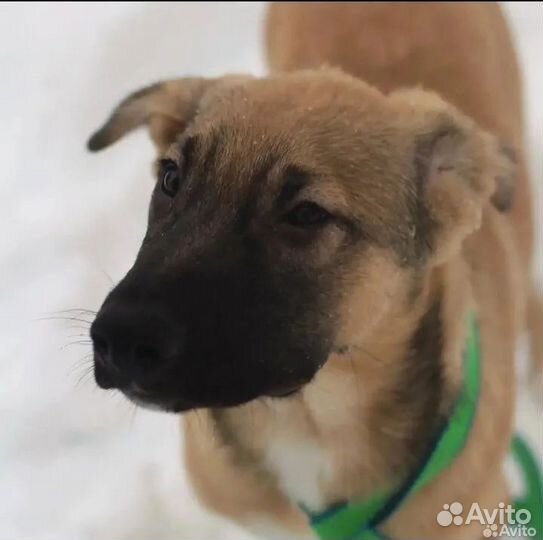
[390,90,516,263]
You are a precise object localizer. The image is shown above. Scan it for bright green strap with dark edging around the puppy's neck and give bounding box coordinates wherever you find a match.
[304,314,543,540]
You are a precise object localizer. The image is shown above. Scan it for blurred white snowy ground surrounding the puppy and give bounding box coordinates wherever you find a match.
[0,2,543,540]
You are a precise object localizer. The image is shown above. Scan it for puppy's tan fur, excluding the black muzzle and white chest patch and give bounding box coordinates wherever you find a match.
[89,3,543,540]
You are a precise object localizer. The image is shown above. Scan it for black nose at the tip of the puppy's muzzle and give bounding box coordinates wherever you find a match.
[90,304,184,389]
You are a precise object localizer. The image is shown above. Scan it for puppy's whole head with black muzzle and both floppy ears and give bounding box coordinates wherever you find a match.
[89,70,510,411]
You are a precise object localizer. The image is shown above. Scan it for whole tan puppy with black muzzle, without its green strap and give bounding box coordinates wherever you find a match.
[89,3,540,540]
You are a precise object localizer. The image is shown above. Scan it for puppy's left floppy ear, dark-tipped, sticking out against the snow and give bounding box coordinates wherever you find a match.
[87,78,212,152]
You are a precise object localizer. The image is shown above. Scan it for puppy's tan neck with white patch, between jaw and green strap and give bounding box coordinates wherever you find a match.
[212,255,470,511]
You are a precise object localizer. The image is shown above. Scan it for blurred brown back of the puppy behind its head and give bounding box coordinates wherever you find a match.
[266,2,537,344]
